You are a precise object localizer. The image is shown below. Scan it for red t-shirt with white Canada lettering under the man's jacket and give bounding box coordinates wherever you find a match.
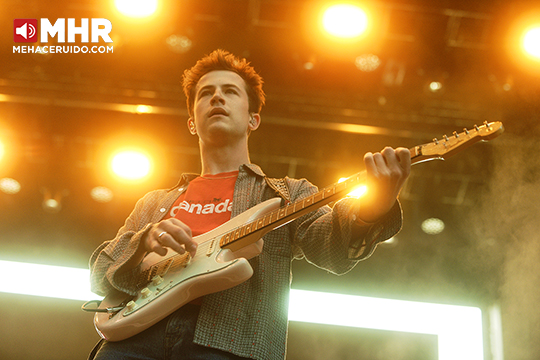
[165,171,238,236]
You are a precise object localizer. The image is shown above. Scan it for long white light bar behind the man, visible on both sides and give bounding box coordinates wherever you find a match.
[0,260,484,360]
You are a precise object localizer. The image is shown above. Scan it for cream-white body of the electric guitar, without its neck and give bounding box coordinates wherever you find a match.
[94,198,281,341]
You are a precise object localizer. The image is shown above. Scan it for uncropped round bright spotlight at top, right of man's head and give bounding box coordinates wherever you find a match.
[322,4,368,39]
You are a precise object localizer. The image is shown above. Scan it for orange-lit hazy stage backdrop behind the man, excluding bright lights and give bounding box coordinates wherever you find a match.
[0,0,540,360]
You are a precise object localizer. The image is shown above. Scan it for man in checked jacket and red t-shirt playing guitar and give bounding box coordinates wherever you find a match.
[90,50,411,360]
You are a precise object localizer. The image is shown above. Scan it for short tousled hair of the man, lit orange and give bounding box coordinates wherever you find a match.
[182,49,265,116]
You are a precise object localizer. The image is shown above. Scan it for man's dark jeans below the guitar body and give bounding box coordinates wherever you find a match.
[89,304,243,360]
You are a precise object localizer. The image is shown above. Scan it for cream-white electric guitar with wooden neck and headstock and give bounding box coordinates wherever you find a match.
[83,122,504,341]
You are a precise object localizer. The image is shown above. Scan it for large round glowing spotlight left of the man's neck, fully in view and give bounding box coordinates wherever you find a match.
[111,150,152,180]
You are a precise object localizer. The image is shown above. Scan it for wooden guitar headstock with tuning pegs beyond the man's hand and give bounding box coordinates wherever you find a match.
[410,121,504,164]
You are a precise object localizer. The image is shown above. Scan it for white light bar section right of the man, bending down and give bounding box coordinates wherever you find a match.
[289,289,484,360]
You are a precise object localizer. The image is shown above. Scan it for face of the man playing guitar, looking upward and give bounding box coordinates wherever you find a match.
[190,70,258,142]
